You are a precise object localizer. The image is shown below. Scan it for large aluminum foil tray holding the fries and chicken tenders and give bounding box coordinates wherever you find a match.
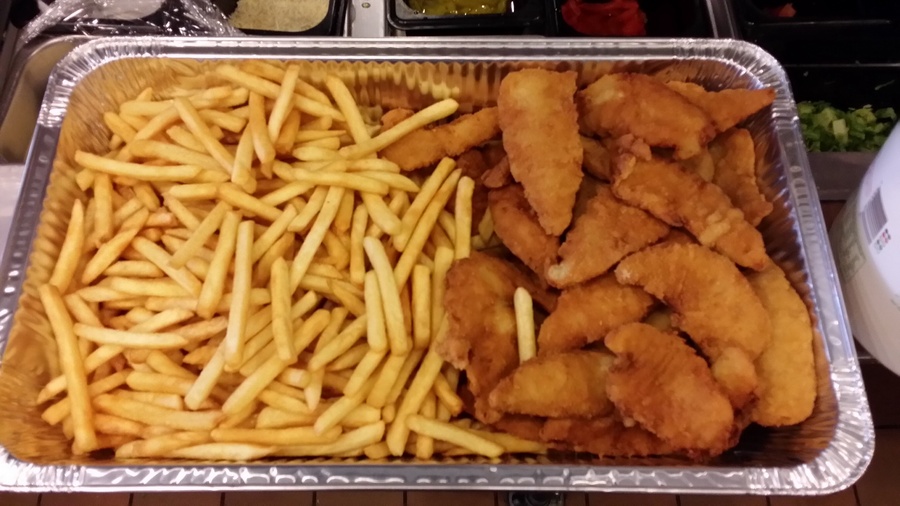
[0,38,874,495]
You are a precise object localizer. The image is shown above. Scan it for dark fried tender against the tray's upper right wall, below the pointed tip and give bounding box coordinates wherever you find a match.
[709,128,772,227]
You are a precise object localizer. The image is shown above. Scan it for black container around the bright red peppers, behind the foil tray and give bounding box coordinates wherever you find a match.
[547,0,712,37]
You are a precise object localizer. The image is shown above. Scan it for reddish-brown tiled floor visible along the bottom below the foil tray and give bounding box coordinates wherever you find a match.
[0,202,884,506]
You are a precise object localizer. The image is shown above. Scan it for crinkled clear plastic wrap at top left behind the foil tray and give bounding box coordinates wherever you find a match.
[19,0,241,47]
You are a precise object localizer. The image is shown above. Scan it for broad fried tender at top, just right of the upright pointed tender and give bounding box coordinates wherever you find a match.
[578,74,716,160]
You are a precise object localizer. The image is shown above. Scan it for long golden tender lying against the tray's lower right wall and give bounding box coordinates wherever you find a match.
[748,264,816,427]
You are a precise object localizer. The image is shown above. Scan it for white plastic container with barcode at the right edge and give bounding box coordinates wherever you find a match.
[830,126,900,375]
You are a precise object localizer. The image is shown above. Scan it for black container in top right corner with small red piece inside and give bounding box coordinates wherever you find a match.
[734,0,900,64]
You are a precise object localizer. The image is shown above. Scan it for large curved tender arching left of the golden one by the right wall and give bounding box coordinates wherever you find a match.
[616,243,772,361]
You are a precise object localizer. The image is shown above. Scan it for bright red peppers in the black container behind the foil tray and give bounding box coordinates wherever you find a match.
[561,0,647,37]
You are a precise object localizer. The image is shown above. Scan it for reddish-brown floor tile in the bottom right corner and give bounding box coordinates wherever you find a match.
[856,429,900,506]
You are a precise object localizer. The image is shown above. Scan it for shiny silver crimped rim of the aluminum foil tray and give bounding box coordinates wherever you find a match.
[0,37,875,495]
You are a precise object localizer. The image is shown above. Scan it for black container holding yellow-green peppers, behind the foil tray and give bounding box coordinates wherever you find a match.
[384,0,545,36]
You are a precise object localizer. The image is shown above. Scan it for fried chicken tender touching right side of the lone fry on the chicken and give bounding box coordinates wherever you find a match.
[538,273,653,356]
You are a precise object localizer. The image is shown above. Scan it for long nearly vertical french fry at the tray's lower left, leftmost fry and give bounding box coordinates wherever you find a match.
[31,284,97,451]
